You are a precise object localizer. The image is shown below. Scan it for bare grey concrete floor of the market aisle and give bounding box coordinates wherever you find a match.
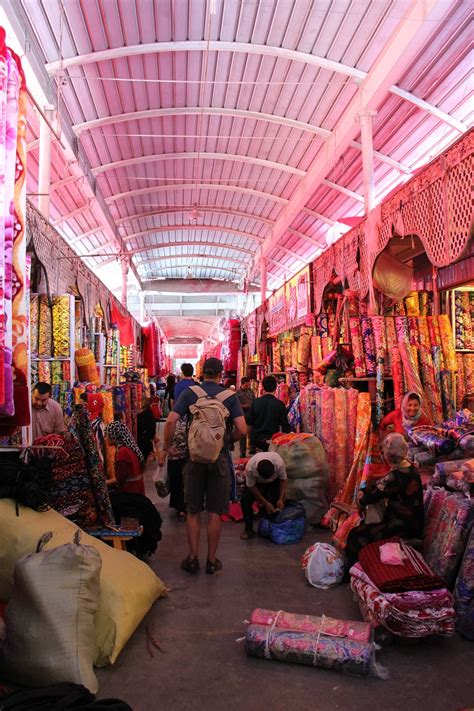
[98,472,474,711]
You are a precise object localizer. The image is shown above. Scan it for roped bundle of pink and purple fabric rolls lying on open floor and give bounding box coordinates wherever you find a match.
[245,608,385,677]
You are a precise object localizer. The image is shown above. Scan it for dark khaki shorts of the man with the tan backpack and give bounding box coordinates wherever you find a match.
[183,452,231,515]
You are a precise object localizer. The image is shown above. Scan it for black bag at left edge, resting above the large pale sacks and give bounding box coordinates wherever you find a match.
[0,453,52,516]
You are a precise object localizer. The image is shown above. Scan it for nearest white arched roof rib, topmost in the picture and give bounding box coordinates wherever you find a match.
[46,41,468,133]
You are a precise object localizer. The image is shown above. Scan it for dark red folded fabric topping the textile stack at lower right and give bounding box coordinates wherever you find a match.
[359,538,446,593]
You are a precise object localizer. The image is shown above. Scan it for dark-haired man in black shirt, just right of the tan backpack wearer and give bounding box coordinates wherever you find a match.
[247,375,290,454]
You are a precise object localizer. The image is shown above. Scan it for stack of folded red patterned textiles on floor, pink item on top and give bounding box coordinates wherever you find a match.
[350,539,455,638]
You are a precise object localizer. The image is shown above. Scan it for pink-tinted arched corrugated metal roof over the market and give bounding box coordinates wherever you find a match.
[6,0,472,338]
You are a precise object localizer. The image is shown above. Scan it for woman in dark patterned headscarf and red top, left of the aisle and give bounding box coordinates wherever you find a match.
[105,421,145,494]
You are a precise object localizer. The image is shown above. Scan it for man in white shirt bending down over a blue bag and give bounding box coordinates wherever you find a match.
[240,452,287,541]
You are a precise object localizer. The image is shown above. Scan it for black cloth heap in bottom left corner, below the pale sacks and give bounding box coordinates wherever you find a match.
[0,683,133,711]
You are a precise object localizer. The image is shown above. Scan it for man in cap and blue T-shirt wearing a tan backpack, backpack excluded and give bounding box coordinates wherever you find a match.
[164,358,247,575]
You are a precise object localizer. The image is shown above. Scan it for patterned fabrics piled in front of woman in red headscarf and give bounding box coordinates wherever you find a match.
[408,409,474,465]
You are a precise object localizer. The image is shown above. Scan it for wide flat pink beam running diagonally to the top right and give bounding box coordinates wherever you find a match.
[250,0,452,276]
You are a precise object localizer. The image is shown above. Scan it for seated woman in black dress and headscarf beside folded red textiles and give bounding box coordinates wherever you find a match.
[346,432,424,566]
